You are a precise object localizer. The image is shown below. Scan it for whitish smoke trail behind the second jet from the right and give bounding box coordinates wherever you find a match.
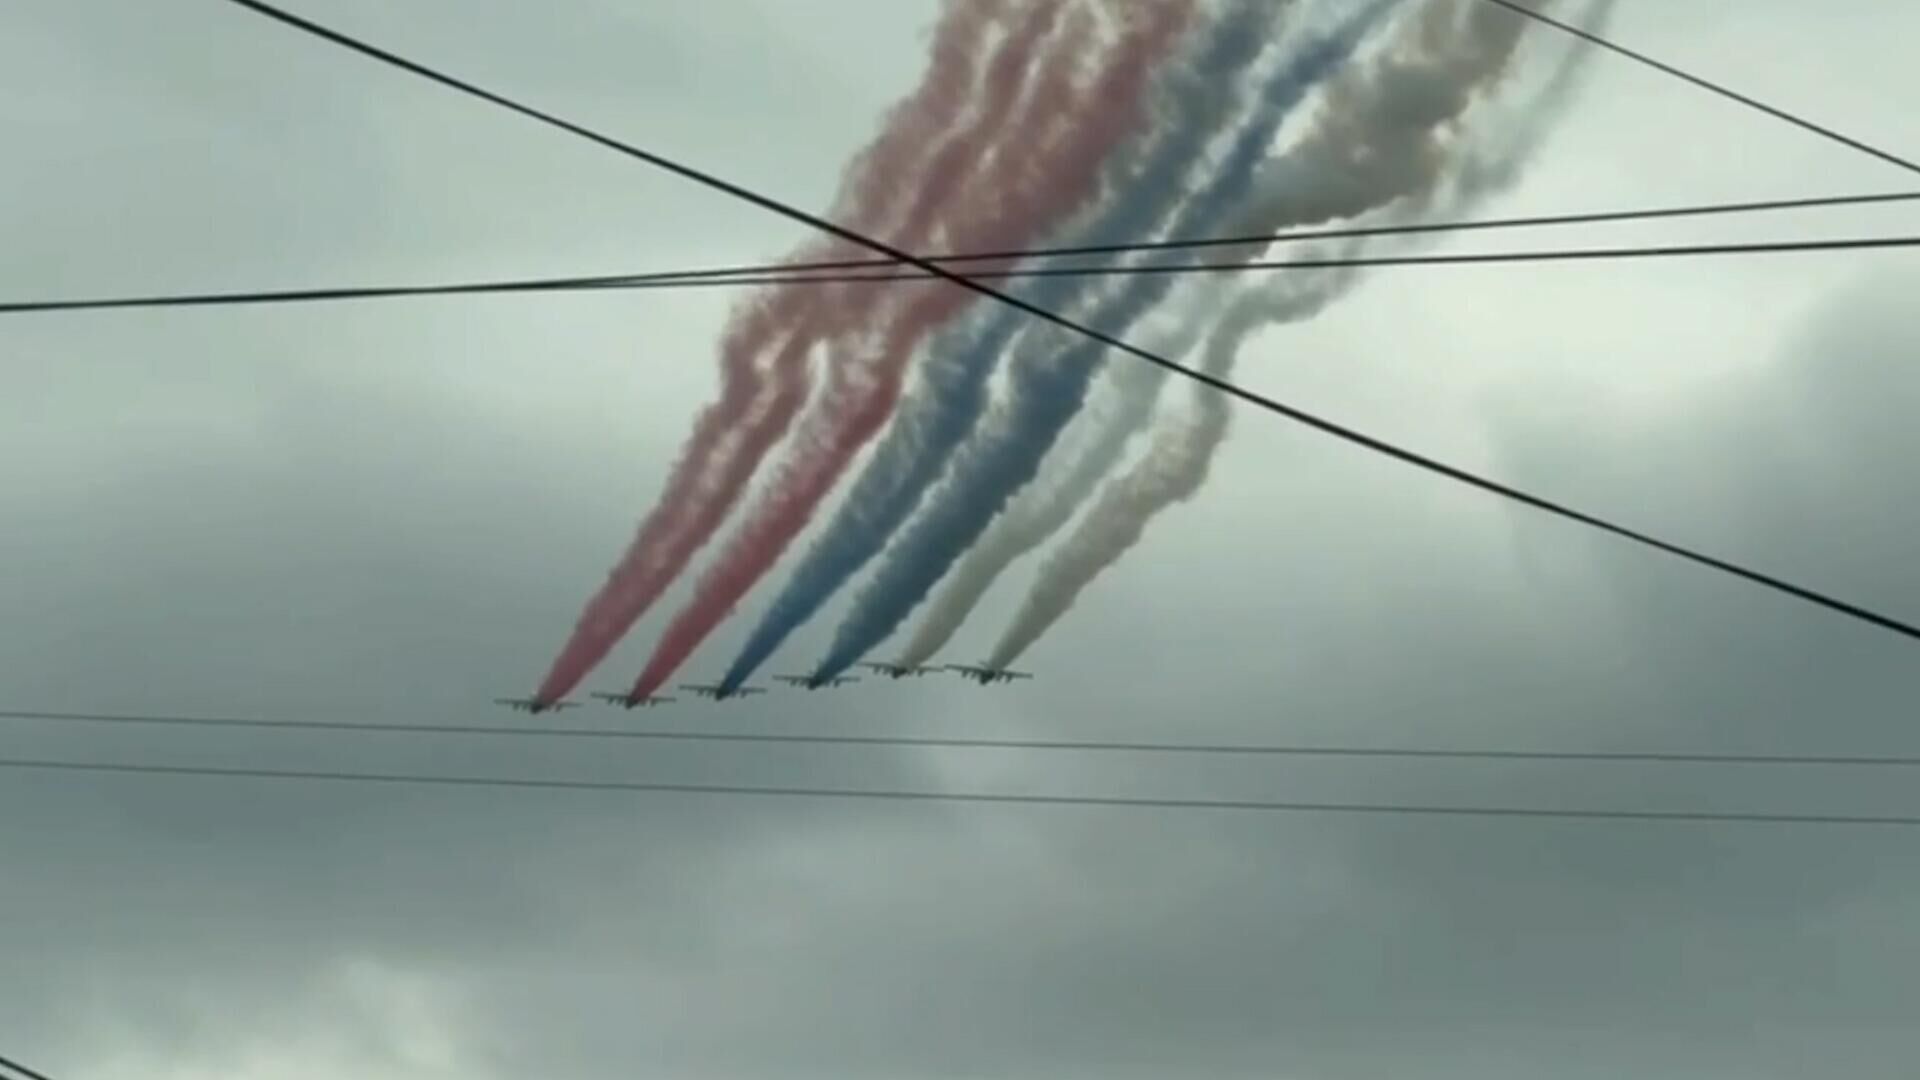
[899,0,1559,665]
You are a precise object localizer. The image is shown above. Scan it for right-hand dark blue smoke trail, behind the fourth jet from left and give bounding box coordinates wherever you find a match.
[820,0,1396,673]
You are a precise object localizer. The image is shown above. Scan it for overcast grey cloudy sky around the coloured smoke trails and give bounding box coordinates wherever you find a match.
[0,0,1920,1080]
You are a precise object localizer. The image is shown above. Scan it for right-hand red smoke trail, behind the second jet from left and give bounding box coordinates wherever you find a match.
[634,0,1192,694]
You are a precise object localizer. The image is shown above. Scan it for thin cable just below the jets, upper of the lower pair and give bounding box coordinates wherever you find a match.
[11,711,1920,769]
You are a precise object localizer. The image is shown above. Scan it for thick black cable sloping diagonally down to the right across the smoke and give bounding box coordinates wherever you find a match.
[228,0,1920,642]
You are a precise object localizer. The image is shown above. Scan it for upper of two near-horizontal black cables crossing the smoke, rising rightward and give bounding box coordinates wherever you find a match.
[11,192,1920,315]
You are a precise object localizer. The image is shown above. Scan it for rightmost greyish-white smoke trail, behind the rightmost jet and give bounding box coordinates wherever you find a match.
[987,0,1613,667]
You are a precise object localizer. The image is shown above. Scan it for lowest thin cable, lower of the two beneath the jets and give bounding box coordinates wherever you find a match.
[0,757,1920,828]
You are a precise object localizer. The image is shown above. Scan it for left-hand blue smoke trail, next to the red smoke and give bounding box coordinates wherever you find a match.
[722,0,1283,686]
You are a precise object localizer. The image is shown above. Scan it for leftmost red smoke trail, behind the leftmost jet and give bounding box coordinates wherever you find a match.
[536,0,1012,701]
